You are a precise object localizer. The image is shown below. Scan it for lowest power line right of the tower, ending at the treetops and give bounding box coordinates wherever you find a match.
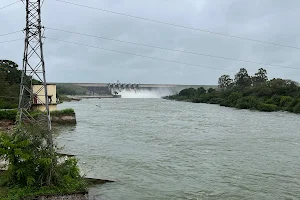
[47,37,234,72]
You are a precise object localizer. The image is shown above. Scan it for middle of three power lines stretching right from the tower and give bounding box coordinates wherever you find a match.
[45,27,299,70]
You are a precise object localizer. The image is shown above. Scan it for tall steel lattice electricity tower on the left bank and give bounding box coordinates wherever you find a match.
[18,0,53,147]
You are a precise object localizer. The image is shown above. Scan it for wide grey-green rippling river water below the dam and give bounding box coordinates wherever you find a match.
[56,98,300,200]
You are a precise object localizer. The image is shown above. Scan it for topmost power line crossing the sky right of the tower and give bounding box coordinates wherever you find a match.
[55,0,300,50]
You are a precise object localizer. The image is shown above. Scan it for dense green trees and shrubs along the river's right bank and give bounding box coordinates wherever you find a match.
[165,68,300,113]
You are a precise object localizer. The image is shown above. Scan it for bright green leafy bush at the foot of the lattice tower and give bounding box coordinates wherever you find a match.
[0,126,86,199]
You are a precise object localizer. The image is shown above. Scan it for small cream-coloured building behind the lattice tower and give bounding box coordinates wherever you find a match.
[32,84,57,111]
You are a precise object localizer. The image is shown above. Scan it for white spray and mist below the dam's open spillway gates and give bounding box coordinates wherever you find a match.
[119,89,174,98]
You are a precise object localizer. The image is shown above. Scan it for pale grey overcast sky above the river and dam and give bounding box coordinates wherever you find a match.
[0,0,300,84]
